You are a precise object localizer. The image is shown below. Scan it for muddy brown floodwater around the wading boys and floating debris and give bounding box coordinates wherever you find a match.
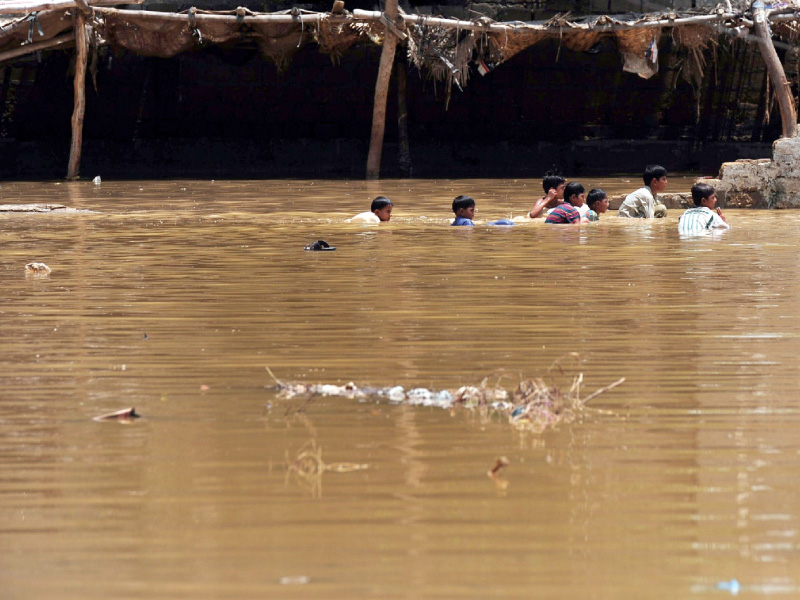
[0,177,800,600]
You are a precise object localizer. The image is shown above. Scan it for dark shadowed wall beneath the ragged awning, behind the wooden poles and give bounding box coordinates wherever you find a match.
[0,31,780,178]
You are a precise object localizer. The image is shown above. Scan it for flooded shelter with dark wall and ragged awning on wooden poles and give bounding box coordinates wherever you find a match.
[0,0,800,179]
